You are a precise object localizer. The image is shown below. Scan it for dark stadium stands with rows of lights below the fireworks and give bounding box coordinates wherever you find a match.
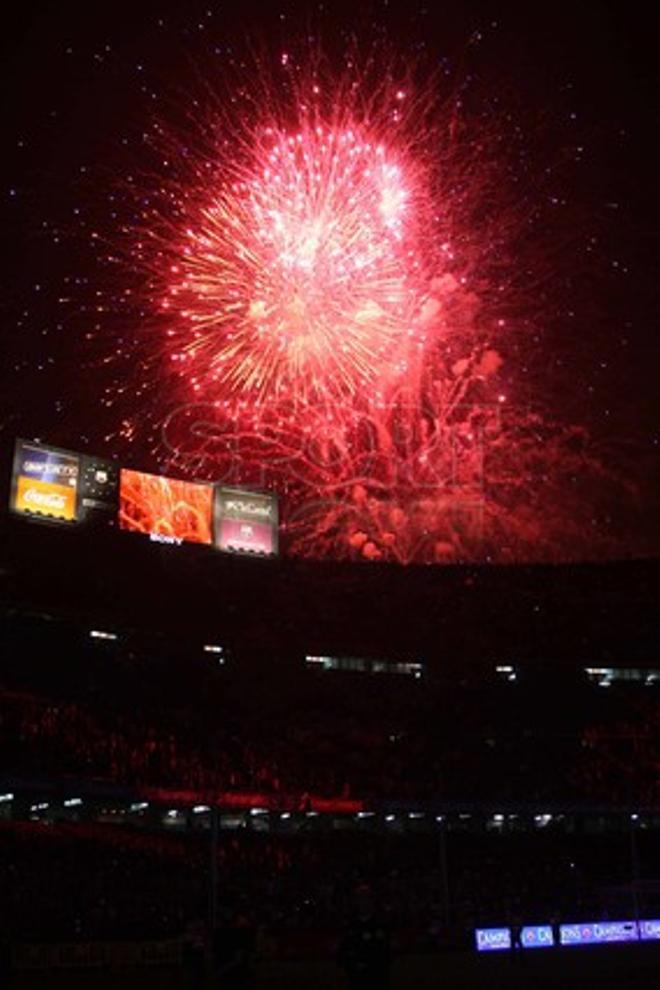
[0,490,660,986]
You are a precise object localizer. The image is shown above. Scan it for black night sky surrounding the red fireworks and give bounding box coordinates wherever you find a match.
[0,0,660,557]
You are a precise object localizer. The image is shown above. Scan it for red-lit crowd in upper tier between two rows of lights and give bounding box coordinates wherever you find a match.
[0,671,660,806]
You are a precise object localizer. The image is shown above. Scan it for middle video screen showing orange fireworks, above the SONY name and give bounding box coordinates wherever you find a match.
[119,468,213,543]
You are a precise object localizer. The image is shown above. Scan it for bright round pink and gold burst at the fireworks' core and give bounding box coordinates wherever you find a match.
[163,122,434,403]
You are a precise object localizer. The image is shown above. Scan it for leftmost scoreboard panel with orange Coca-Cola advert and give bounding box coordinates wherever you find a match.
[11,440,80,522]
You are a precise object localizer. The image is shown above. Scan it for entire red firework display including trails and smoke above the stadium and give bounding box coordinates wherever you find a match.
[103,50,624,562]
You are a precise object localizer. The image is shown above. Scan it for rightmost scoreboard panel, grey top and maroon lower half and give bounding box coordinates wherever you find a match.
[215,488,278,556]
